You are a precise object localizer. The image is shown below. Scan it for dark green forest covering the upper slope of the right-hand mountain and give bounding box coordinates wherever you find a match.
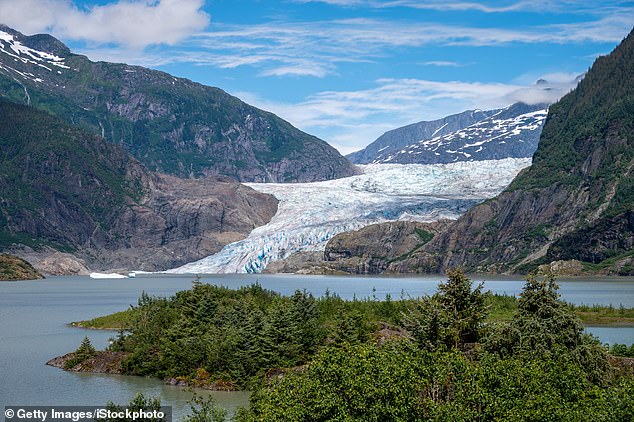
[509,30,634,193]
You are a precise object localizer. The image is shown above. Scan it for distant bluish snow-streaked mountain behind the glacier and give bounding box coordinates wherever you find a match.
[348,103,548,164]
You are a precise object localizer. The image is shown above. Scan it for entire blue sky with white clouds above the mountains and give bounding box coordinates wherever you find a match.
[0,0,634,154]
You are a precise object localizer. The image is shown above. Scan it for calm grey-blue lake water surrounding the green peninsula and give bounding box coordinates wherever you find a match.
[0,274,634,421]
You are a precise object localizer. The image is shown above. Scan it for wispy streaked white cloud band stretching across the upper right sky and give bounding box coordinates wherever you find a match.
[130,13,634,77]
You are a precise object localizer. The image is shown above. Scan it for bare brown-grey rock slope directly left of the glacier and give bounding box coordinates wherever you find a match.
[87,176,277,271]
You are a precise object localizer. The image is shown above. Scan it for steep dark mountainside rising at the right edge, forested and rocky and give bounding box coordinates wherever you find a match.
[394,28,634,274]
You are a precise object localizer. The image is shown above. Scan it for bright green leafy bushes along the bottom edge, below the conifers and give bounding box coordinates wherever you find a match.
[238,342,634,421]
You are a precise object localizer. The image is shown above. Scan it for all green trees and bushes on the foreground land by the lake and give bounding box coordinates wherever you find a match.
[81,271,634,421]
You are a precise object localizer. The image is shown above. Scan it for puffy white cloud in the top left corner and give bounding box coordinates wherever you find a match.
[0,0,210,49]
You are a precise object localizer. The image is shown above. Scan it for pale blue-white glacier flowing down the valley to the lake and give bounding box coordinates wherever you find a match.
[166,158,531,274]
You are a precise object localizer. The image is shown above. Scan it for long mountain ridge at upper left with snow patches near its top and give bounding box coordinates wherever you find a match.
[0,26,355,182]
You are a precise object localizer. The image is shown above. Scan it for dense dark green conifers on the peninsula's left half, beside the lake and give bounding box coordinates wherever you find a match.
[110,282,414,388]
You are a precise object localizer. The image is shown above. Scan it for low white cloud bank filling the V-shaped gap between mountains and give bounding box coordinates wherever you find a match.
[234,74,576,154]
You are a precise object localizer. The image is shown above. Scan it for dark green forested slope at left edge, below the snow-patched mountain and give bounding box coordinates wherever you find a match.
[0,98,144,251]
